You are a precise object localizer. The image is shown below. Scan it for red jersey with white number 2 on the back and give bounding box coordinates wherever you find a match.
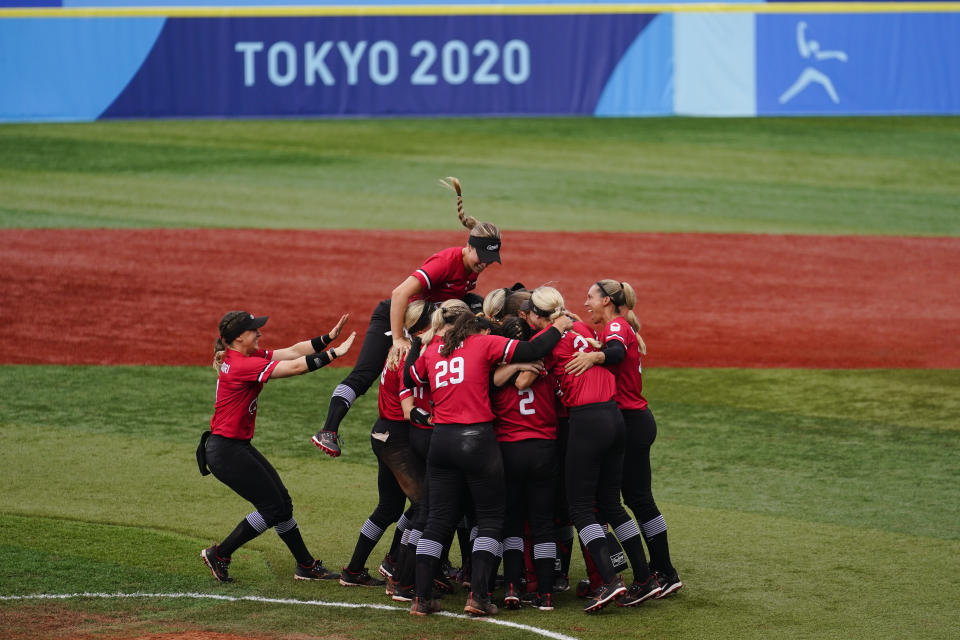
[493,371,557,442]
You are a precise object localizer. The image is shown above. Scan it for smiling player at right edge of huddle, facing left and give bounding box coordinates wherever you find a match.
[566,280,683,598]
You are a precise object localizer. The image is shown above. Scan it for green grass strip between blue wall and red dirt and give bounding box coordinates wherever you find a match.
[0,118,960,235]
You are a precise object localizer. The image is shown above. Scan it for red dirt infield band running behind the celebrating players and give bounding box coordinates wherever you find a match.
[0,229,960,368]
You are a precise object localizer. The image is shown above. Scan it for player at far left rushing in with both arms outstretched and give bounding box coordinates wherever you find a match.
[197,311,356,582]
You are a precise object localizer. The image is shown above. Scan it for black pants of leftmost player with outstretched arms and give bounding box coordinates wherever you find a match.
[207,434,293,527]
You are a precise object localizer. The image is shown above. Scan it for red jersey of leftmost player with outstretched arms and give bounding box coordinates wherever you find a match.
[210,349,279,440]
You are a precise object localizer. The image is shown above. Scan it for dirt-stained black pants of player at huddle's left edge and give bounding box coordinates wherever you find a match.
[370,418,426,528]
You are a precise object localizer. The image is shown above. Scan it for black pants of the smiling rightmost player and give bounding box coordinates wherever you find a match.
[622,409,660,523]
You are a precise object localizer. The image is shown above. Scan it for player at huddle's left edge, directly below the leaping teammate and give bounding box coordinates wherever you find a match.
[340,300,429,595]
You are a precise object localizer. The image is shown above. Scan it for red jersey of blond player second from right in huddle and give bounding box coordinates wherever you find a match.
[537,322,617,407]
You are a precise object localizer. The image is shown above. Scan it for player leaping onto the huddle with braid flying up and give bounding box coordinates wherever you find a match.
[313,178,500,458]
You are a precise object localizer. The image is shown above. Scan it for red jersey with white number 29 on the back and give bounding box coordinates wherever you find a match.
[410,335,517,424]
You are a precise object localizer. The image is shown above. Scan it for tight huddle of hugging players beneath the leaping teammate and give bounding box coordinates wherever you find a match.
[340,280,682,615]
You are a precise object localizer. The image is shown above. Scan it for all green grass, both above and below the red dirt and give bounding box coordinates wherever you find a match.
[0,118,960,640]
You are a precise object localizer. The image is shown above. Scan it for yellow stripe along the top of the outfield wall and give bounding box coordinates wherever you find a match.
[0,2,960,18]
